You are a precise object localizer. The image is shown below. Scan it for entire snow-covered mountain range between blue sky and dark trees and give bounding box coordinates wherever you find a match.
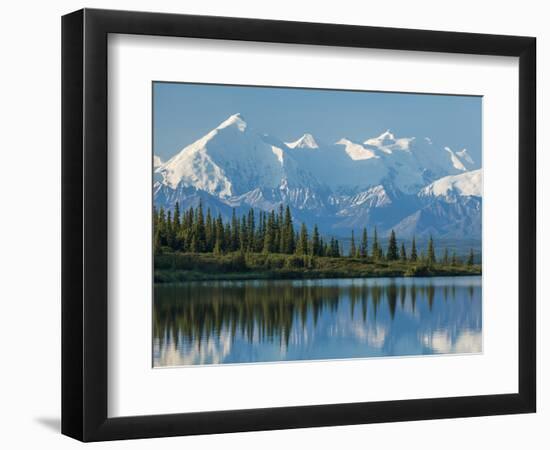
[154,114,482,238]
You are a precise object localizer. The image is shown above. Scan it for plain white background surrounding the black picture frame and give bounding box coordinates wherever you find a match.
[0,0,550,450]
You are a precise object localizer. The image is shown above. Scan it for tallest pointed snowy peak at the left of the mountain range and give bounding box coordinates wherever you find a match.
[158,114,319,199]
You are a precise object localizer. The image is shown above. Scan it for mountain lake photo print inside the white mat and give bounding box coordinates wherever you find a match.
[152,82,482,367]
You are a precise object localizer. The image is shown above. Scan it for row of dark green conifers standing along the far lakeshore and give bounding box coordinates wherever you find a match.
[153,202,474,266]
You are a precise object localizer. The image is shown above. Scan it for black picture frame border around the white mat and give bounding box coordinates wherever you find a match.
[62,9,536,441]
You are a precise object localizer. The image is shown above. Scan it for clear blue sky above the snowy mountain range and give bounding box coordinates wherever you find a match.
[153,82,482,162]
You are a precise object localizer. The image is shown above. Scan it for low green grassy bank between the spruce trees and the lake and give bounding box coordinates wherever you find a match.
[154,252,481,283]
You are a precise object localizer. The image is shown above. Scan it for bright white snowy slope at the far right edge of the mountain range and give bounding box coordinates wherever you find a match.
[418,169,483,200]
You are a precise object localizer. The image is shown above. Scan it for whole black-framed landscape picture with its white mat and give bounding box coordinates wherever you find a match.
[62,9,536,441]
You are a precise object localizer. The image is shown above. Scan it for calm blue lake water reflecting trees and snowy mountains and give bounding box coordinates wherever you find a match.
[153,276,482,367]
